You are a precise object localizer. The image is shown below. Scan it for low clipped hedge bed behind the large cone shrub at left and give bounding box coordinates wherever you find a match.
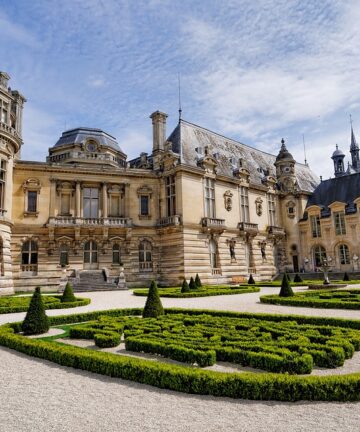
[0,295,91,314]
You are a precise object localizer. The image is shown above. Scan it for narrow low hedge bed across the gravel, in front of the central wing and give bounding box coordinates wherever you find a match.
[133,285,260,298]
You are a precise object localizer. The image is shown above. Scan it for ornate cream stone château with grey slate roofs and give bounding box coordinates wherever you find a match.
[0,72,360,294]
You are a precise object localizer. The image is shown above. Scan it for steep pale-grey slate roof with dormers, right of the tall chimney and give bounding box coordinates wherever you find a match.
[168,120,319,192]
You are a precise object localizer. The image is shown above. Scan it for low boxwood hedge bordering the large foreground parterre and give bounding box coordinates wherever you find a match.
[0,309,360,401]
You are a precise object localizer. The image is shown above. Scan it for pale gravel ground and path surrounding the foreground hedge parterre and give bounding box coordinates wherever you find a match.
[0,288,360,432]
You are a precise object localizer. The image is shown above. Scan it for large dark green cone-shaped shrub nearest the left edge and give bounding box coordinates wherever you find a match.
[21,287,50,335]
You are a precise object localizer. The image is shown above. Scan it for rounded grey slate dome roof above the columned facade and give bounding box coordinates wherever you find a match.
[54,127,124,153]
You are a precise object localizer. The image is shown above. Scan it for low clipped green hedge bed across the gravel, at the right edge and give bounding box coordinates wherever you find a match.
[260,289,360,309]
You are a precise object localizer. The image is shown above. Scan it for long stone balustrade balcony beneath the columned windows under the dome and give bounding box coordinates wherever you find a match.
[48,216,132,228]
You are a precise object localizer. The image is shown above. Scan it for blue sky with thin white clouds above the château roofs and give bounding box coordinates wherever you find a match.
[0,0,360,178]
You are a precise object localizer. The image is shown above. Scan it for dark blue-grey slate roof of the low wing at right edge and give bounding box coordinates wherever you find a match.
[306,173,360,213]
